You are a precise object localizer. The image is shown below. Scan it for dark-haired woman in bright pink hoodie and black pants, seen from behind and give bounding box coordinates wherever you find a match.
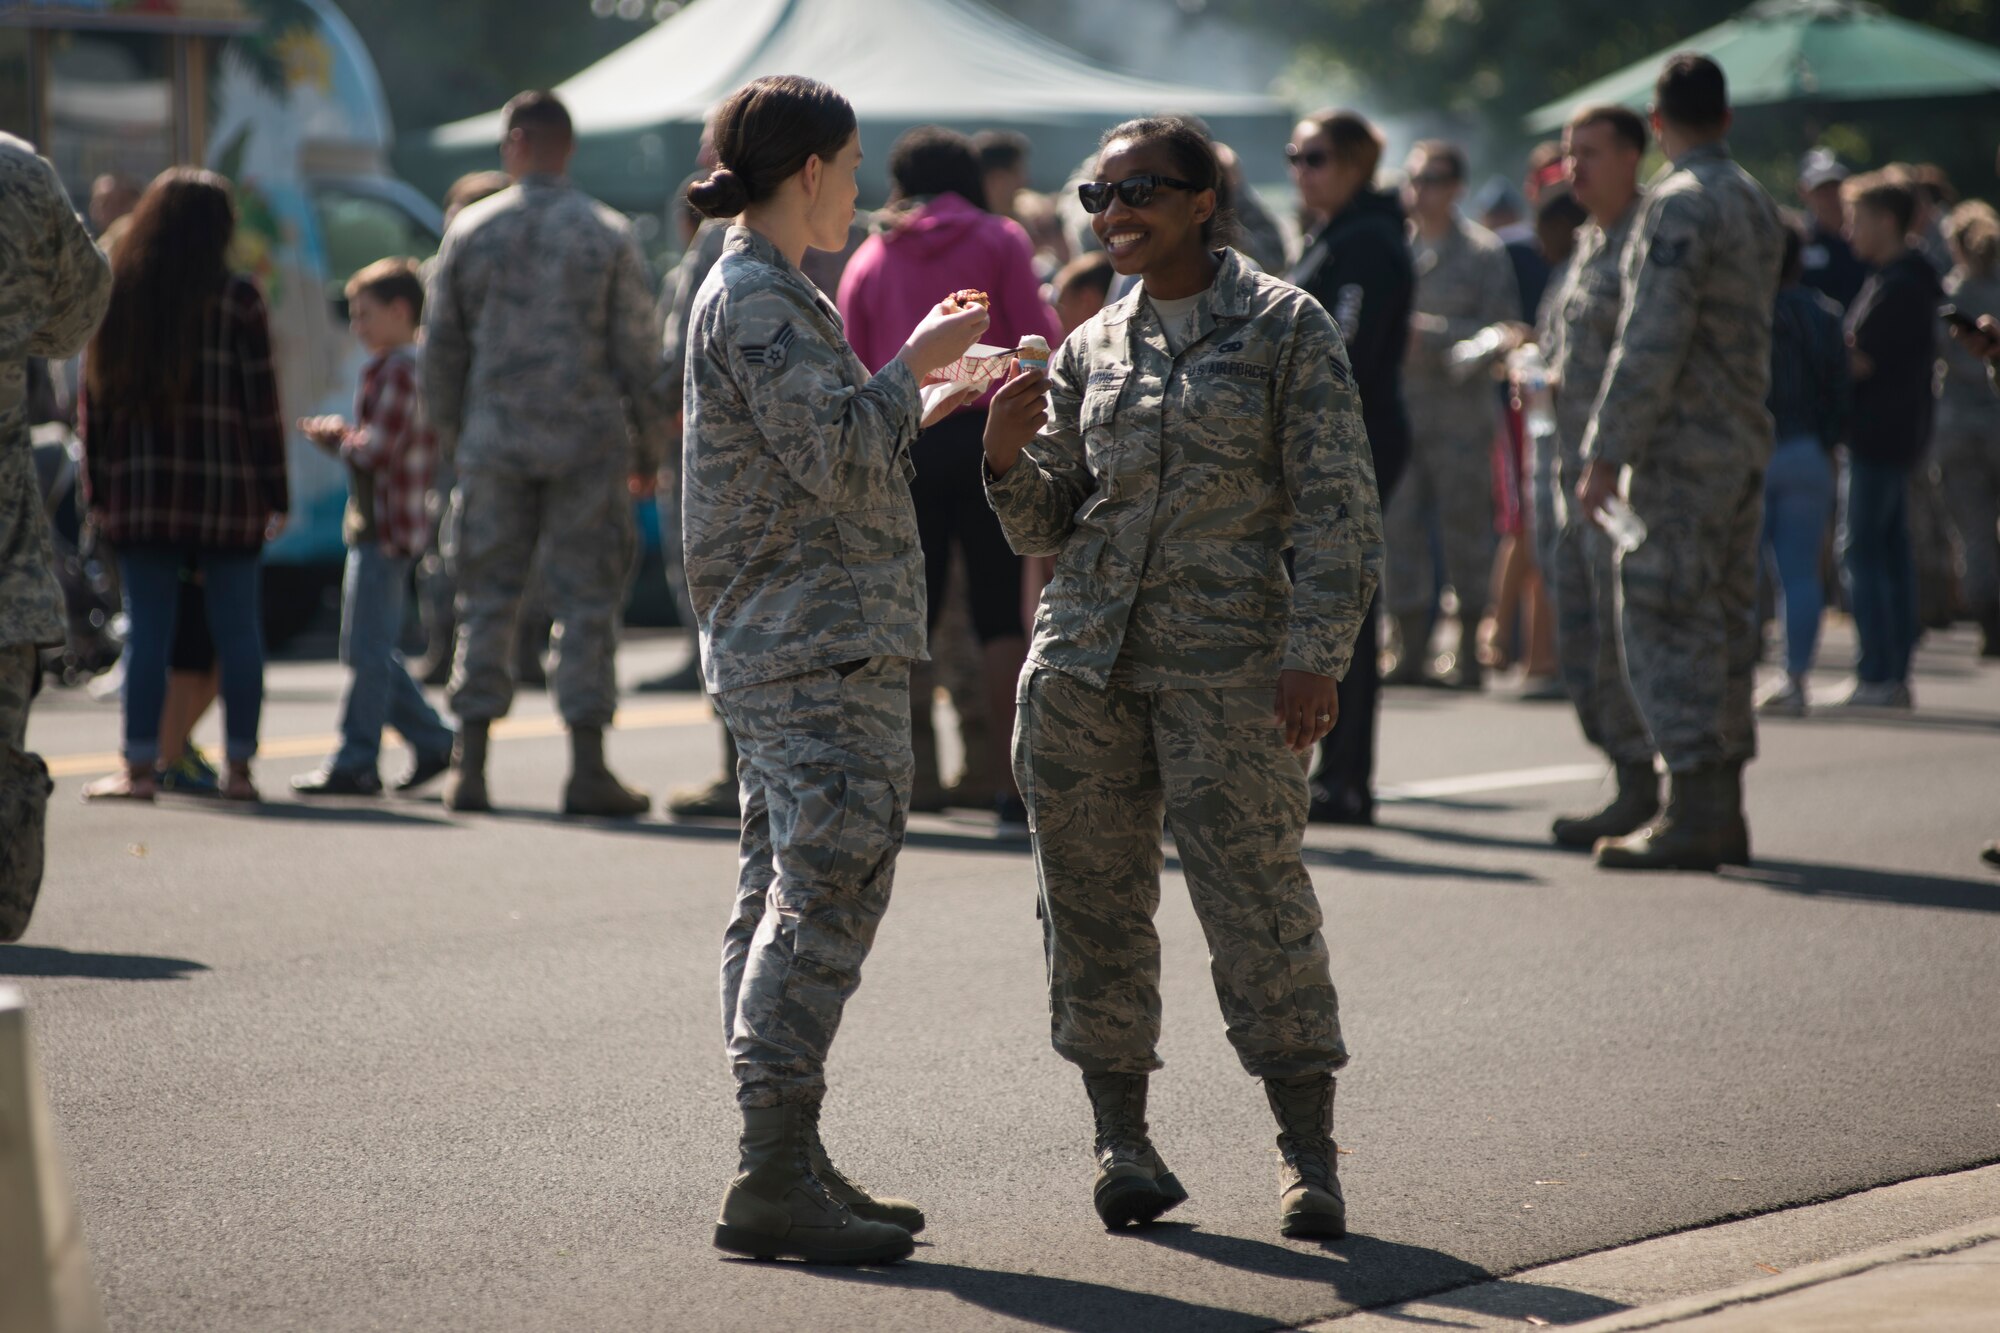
[838,126,1062,827]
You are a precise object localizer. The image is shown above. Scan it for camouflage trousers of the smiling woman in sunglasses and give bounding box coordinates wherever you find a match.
[1014,662,1348,1079]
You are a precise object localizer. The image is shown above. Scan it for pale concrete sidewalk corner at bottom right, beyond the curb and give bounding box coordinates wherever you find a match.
[1570,1217,2000,1333]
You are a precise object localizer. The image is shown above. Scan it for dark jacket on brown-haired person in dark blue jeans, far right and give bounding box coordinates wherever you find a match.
[1848,250,1944,466]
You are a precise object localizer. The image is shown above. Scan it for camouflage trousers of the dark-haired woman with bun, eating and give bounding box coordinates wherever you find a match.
[716,656,912,1107]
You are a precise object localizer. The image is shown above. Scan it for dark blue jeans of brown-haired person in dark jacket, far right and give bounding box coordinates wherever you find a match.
[1840,458,1920,685]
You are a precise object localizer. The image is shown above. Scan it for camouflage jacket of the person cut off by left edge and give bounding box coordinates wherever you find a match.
[0,134,112,646]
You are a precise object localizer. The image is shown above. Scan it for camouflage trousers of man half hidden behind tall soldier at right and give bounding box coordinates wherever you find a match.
[1544,476,1652,765]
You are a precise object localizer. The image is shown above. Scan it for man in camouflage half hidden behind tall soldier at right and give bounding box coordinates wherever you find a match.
[1536,106,1660,849]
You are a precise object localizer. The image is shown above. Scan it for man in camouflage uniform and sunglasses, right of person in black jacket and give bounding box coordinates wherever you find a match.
[1384,140,1520,689]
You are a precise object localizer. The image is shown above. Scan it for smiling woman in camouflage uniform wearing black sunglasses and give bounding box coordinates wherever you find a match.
[984,118,1382,1237]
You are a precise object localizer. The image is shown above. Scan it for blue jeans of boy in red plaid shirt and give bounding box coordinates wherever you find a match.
[328,542,452,779]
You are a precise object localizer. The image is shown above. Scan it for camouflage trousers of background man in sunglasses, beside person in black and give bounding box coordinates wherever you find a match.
[1382,412,1498,626]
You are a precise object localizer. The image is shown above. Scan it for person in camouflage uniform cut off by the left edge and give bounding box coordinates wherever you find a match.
[0,134,112,941]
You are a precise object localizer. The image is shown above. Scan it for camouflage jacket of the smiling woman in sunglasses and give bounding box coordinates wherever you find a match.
[986,252,1382,689]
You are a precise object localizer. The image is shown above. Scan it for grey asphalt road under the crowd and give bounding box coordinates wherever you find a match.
[15,634,2000,1333]
